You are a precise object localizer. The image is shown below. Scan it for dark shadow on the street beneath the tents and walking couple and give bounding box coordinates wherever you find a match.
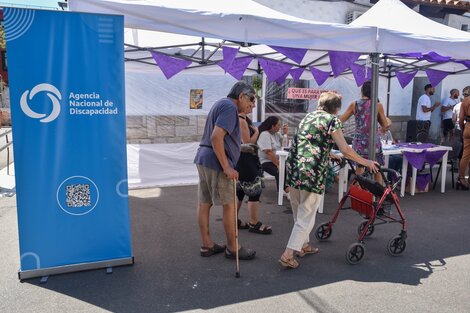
[27,182,470,312]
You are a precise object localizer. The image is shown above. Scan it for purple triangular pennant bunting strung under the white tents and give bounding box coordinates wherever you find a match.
[151,46,470,88]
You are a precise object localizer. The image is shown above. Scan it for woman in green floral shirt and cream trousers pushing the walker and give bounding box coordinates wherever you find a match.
[279,92,379,268]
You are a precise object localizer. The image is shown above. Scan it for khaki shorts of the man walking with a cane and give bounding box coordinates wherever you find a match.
[196,165,235,205]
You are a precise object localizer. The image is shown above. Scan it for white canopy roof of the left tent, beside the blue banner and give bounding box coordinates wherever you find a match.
[69,0,376,53]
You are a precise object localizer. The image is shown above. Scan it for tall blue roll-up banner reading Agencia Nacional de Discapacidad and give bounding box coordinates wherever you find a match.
[4,8,133,278]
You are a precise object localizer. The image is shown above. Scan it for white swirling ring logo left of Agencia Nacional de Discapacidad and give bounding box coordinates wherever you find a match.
[20,83,62,123]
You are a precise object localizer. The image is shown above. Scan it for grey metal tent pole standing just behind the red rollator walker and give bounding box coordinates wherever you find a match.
[369,53,379,160]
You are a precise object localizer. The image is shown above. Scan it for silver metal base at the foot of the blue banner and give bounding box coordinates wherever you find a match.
[18,256,134,281]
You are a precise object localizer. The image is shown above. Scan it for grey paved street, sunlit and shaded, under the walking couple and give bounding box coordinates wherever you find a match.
[0,175,470,313]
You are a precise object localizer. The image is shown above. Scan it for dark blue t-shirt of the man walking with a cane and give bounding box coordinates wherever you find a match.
[194,98,241,171]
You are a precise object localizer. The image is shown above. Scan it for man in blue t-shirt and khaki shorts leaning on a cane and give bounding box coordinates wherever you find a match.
[194,81,256,275]
